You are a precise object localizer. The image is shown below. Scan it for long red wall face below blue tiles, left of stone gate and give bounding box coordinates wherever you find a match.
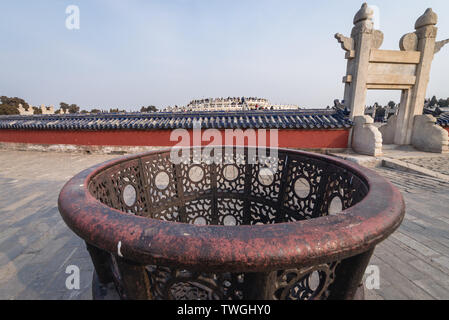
[0,129,349,149]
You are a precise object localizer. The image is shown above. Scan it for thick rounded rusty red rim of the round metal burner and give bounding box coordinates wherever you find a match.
[58,149,405,272]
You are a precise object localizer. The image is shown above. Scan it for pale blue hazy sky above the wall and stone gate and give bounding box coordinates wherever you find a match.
[0,0,449,110]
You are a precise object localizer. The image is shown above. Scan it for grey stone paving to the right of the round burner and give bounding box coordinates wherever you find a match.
[367,168,449,300]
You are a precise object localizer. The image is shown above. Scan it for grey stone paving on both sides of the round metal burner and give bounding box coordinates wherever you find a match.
[0,151,449,299]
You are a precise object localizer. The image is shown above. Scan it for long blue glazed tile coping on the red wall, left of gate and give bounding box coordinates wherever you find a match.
[0,109,352,130]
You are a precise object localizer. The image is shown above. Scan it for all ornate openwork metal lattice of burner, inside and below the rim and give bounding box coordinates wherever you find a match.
[79,148,378,300]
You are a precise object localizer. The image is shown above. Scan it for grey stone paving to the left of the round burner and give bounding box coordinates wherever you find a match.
[0,151,117,299]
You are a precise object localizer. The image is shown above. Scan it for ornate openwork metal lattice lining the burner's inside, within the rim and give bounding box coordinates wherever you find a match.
[89,148,368,225]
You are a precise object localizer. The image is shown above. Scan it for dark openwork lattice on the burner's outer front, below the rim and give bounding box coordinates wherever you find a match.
[119,262,339,300]
